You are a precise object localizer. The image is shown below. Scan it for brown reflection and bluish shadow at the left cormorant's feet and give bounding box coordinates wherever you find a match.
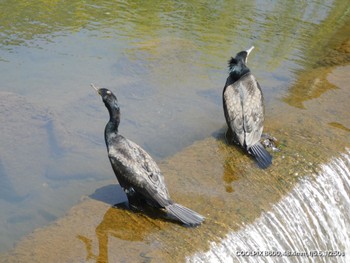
[77,185,161,262]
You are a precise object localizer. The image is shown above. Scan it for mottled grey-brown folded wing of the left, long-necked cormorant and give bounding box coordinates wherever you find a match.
[108,136,170,207]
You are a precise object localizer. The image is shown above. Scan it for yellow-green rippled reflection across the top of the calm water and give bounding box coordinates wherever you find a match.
[0,0,348,68]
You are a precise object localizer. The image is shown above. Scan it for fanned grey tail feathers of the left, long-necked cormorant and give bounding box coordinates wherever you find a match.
[165,203,204,226]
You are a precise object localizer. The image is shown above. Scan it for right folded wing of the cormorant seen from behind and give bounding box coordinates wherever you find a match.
[240,74,264,149]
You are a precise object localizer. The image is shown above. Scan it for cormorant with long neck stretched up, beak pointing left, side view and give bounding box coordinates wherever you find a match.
[91,84,204,226]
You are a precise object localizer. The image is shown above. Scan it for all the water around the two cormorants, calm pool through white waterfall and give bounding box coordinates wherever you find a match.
[0,0,350,262]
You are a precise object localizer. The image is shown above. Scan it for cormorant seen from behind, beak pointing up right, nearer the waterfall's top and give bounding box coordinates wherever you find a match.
[222,46,272,169]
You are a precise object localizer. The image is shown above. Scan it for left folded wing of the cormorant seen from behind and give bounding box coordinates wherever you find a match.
[222,82,244,146]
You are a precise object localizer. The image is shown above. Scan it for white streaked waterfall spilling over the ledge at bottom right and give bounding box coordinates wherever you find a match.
[187,150,350,263]
